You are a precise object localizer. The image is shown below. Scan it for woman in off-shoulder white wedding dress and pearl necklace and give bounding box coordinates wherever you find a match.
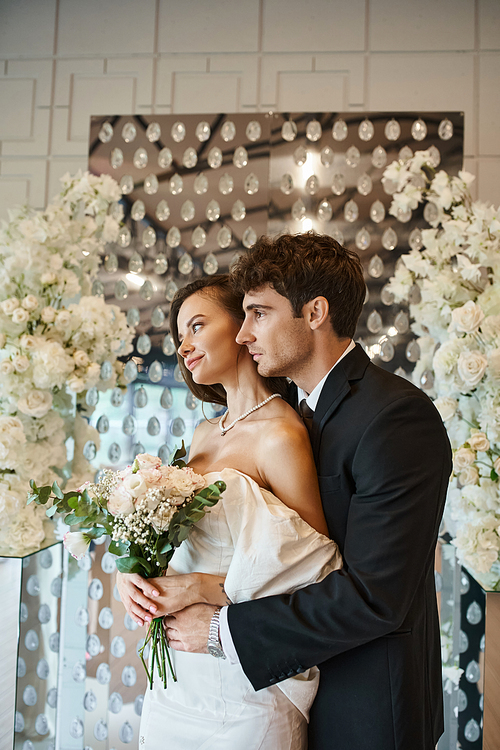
[118,275,341,750]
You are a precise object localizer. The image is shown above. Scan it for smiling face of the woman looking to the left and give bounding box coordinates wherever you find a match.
[177,292,246,385]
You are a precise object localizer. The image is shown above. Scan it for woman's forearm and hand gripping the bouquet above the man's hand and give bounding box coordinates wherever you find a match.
[116,568,231,626]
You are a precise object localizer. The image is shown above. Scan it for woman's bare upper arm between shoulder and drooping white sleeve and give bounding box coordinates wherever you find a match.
[258,420,329,536]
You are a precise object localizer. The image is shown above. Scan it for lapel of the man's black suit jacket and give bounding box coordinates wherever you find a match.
[311,344,370,456]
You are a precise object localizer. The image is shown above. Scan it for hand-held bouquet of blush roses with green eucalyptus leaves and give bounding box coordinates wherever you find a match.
[28,444,226,688]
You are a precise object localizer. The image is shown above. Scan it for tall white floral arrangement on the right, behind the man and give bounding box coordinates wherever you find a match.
[383,151,500,589]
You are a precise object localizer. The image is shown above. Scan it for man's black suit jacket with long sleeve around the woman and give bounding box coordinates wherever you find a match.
[228,345,451,750]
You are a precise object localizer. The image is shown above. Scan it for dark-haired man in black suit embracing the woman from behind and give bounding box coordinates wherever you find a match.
[166,233,451,750]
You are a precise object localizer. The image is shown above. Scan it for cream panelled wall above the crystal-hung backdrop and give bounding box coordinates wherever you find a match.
[0,0,500,215]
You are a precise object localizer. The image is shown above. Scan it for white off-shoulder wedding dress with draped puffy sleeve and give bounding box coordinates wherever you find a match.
[139,469,342,750]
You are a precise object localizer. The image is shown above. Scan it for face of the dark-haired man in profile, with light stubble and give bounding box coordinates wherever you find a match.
[236,285,313,382]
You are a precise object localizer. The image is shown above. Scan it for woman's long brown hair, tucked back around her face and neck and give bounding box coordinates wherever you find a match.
[170,274,288,406]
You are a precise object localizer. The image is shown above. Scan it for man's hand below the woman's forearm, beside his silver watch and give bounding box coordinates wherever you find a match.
[163,604,217,654]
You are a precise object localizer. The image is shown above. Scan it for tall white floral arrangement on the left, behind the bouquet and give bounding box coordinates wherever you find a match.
[0,172,134,552]
